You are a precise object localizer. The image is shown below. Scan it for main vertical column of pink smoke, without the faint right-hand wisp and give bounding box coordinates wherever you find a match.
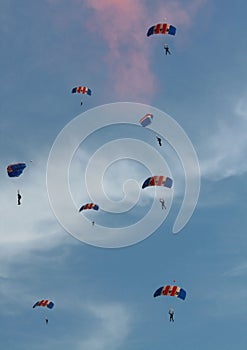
[86,0,155,100]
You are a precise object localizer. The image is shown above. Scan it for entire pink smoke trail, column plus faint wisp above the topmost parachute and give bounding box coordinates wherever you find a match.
[83,0,206,103]
